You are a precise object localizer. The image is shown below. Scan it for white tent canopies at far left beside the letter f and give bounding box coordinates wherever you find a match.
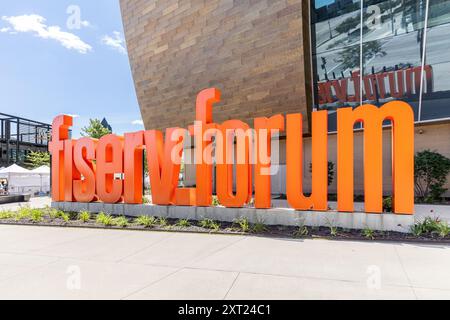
[0,164,50,194]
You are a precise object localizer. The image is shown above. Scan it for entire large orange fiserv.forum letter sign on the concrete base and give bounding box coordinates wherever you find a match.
[49,88,414,214]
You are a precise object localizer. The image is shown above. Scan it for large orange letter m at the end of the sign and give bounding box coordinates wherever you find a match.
[337,101,414,214]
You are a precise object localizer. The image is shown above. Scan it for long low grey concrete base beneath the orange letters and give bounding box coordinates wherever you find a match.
[52,202,414,233]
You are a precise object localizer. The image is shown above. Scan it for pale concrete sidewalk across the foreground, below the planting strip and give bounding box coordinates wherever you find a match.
[0,222,450,299]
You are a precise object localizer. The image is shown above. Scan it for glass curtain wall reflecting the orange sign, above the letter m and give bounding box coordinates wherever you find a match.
[311,0,450,131]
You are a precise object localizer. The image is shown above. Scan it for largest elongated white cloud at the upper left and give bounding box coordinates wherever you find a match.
[2,14,92,54]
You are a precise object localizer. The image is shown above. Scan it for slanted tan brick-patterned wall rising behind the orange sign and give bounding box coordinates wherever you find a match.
[120,0,311,131]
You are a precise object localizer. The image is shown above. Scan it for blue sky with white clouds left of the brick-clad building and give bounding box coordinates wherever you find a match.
[0,0,143,137]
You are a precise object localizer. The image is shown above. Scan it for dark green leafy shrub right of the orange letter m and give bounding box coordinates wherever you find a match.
[414,150,450,202]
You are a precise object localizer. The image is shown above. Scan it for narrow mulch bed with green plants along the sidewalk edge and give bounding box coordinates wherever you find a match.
[0,217,450,245]
